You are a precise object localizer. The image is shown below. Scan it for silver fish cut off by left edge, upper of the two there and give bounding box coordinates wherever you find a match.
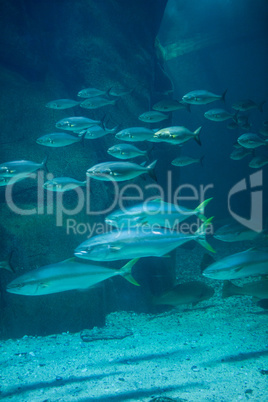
[0,157,47,178]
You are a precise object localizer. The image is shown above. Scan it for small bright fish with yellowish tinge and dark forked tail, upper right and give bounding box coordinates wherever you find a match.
[154,126,202,145]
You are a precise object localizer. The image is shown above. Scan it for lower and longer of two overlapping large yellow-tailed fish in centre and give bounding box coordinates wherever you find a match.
[74,218,214,261]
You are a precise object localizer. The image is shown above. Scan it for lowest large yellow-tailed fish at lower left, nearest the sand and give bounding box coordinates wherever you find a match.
[6,258,138,296]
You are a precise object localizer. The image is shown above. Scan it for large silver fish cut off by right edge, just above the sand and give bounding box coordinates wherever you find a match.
[203,249,268,280]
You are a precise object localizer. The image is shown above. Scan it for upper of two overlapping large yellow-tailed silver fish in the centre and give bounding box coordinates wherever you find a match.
[105,198,212,228]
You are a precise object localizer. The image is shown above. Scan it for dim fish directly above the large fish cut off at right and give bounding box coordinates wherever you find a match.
[214,222,263,243]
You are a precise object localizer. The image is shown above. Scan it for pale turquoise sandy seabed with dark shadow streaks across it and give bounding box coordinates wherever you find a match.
[0,240,268,402]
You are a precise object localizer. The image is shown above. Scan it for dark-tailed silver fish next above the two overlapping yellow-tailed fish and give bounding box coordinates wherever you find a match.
[86,161,157,181]
